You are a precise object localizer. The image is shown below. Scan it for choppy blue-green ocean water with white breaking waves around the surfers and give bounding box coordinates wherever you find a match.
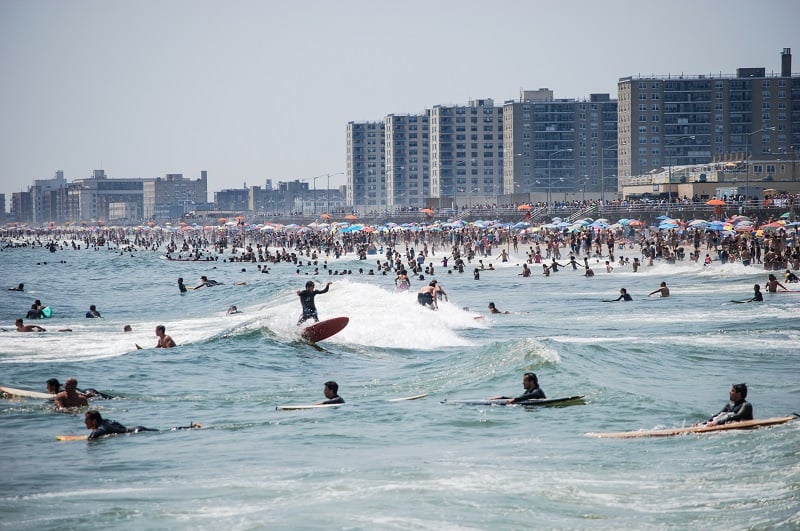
[0,241,800,530]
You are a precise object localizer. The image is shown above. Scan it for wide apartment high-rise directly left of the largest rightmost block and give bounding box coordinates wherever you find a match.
[503,88,617,201]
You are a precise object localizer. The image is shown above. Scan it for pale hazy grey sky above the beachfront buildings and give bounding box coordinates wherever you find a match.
[0,0,800,207]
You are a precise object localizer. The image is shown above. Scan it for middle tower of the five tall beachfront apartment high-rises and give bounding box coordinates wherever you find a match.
[430,99,503,207]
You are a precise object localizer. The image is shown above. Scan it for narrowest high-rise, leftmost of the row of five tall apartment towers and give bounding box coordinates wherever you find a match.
[346,122,386,212]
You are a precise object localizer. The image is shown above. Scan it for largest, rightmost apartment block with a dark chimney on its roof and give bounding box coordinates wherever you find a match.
[618,48,800,181]
